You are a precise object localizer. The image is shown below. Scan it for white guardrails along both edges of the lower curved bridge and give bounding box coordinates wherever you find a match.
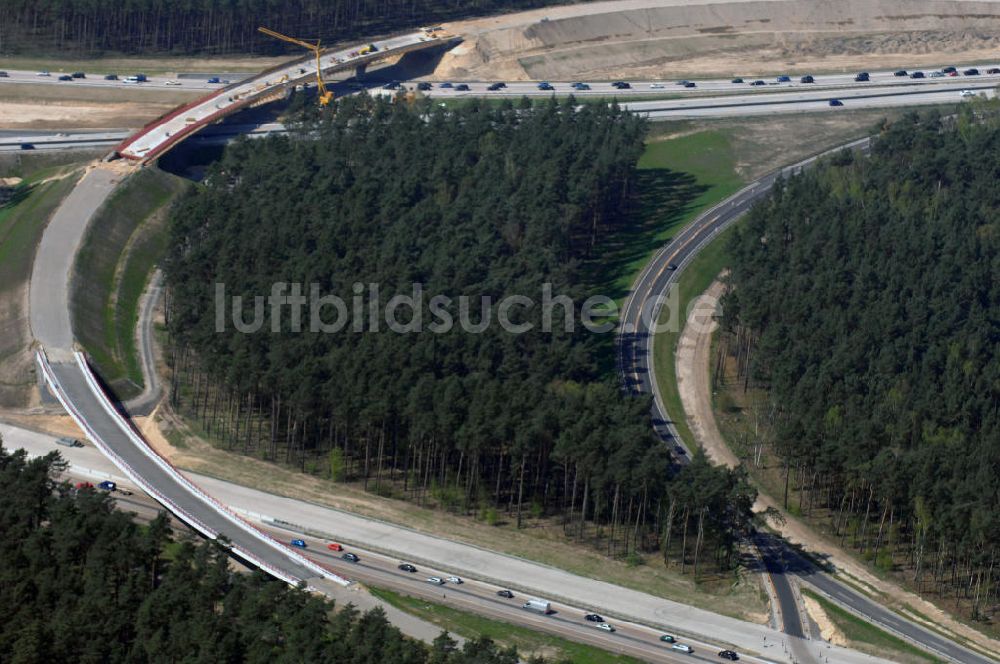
[36,350,351,586]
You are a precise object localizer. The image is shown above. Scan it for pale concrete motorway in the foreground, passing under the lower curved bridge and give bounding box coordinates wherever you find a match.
[0,424,881,664]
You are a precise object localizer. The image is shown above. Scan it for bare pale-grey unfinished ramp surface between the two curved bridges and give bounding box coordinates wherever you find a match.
[29,168,118,361]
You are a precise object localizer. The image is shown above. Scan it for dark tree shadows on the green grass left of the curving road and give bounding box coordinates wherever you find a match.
[583,168,709,376]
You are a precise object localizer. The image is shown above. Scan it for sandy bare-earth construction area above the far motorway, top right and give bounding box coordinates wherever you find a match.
[444,0,1000,80]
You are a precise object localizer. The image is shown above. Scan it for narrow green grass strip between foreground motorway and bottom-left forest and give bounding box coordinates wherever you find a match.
[369,588,641,664]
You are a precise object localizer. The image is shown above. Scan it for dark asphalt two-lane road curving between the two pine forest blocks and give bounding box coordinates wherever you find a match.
[618,138,995,664]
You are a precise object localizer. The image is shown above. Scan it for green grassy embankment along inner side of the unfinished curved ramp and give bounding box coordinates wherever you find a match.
[72,169,187,399]
